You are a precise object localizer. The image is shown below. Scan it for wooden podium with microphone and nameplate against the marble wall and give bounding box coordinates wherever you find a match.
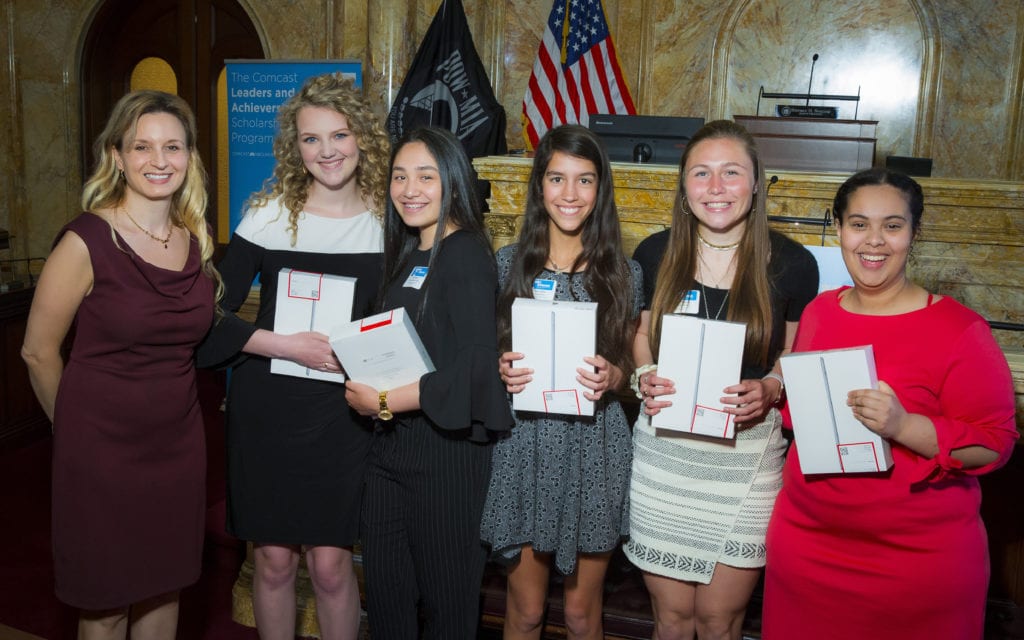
[733,116,879,173]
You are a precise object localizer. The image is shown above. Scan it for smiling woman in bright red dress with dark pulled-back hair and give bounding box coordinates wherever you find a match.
[762,169,1017,640]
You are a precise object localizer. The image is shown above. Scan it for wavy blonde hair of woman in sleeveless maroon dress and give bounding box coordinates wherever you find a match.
[82,90,223,300]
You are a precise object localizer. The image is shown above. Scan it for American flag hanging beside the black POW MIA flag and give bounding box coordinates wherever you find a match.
[522,0,636,148]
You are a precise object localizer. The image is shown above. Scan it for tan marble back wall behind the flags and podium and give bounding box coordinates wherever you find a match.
[0,0,1024,258]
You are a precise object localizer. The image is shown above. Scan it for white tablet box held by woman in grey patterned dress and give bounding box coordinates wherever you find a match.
[512,298,597,416]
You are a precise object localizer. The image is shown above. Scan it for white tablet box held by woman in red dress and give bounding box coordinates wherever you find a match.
[780,345,893,475]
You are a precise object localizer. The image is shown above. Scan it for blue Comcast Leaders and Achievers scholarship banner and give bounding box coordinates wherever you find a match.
[225,60,362,231]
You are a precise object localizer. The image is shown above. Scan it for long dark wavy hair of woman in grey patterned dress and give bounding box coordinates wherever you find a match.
[498,125,635,371]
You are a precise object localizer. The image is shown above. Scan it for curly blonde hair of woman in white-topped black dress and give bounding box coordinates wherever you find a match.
[246,73,391,247]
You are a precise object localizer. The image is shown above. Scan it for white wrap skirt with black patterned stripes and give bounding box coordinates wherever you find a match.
[625,409,785,585]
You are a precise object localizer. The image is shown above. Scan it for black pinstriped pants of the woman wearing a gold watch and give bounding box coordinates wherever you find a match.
[361,418,493,640]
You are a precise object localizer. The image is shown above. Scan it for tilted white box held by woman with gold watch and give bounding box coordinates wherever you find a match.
[331,308,434,391]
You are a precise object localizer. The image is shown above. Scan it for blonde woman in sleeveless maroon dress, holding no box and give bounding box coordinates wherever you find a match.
[23,91,219,640]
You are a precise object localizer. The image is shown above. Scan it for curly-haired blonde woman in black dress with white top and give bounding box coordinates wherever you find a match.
[202,74,389,640]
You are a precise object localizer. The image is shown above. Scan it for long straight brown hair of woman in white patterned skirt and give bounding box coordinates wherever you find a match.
[648,120,772,367]
